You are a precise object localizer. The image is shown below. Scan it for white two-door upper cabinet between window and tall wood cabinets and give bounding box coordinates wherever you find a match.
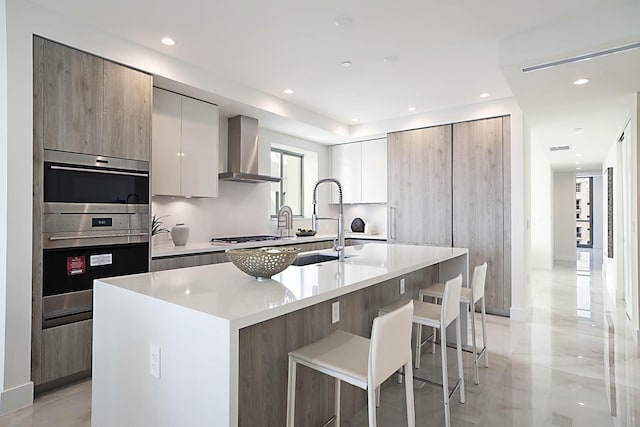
[331,138,387,203]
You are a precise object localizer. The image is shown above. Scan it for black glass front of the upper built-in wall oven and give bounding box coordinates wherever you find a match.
[44,162,149,204]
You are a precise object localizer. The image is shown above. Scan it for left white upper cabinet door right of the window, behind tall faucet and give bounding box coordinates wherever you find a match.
[331,143,362,203]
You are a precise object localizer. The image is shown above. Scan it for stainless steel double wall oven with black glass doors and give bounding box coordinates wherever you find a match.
[42,150,150,328]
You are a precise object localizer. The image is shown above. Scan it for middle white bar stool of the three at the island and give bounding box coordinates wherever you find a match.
[378,274,465,427]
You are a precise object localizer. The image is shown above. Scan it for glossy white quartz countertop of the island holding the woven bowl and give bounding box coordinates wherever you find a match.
[101,243,468,328]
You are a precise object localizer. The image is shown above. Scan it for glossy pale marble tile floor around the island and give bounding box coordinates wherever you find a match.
[0,256,640,427]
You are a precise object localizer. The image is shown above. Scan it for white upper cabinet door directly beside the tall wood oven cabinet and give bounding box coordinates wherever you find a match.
[151,88,182,196]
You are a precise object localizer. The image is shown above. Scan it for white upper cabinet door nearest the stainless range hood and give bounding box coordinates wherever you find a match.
[181,97,218,197]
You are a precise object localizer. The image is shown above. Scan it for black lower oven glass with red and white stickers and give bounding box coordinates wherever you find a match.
[43,243,149,296]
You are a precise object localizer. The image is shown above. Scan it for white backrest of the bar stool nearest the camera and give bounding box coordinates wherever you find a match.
[368,301,413,388]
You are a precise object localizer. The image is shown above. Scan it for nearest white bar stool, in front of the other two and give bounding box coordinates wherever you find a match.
[287,302,415,427]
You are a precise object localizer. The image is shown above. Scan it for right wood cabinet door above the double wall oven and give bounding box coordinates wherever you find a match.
[102,61,152,161]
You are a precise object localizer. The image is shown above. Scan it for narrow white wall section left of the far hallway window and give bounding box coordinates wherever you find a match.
[553,172,576,261]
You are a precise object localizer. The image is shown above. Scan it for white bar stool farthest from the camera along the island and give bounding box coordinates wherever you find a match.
[416,262,489,384]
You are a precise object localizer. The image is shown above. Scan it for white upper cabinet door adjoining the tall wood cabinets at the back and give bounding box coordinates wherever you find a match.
[361,138,387,203]
